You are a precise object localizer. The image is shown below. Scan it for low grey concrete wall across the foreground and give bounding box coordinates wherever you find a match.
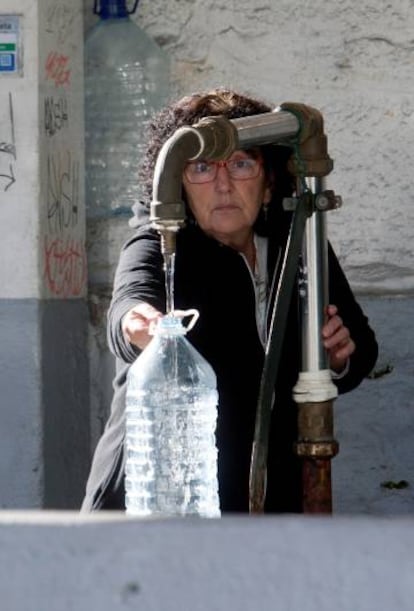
[0,513,414,611]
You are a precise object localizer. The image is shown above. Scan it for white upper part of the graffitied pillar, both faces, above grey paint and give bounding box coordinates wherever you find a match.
[0,0,86,299]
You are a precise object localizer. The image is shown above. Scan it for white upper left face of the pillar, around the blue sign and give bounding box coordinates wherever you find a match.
[0,0,39,298]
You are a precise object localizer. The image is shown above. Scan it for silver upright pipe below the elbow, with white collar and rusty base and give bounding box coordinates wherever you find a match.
[294,177,338,514]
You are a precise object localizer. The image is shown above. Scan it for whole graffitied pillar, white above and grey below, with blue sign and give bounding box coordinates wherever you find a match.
[0,0,89,508]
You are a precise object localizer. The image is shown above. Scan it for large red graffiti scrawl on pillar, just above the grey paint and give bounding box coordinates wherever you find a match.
[44,237,87,298]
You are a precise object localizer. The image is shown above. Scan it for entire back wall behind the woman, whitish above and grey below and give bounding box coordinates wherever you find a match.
[84,0,414,513]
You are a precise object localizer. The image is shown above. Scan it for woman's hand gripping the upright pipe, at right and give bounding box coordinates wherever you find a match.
[322,305,355,373]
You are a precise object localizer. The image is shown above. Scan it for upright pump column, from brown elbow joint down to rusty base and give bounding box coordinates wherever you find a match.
[284,105,340,513]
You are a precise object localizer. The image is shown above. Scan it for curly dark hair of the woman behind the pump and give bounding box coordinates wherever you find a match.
[135,88,294,233]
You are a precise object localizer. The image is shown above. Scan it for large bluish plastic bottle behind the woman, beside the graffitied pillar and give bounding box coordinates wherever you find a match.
[85,0,170,218]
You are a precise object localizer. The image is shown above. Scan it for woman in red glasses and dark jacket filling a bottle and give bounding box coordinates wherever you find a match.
[83,90,377,512]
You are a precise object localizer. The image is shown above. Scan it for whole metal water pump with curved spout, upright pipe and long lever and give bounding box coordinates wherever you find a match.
[150,103,339,513]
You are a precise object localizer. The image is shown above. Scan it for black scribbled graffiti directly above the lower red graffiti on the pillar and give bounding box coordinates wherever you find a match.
[47,151,80,234]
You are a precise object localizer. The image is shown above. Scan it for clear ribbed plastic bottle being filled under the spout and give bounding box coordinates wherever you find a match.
[125,310,220,518]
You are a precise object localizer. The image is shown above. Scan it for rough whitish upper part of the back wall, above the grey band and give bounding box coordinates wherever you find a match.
[85,0,414,293]
